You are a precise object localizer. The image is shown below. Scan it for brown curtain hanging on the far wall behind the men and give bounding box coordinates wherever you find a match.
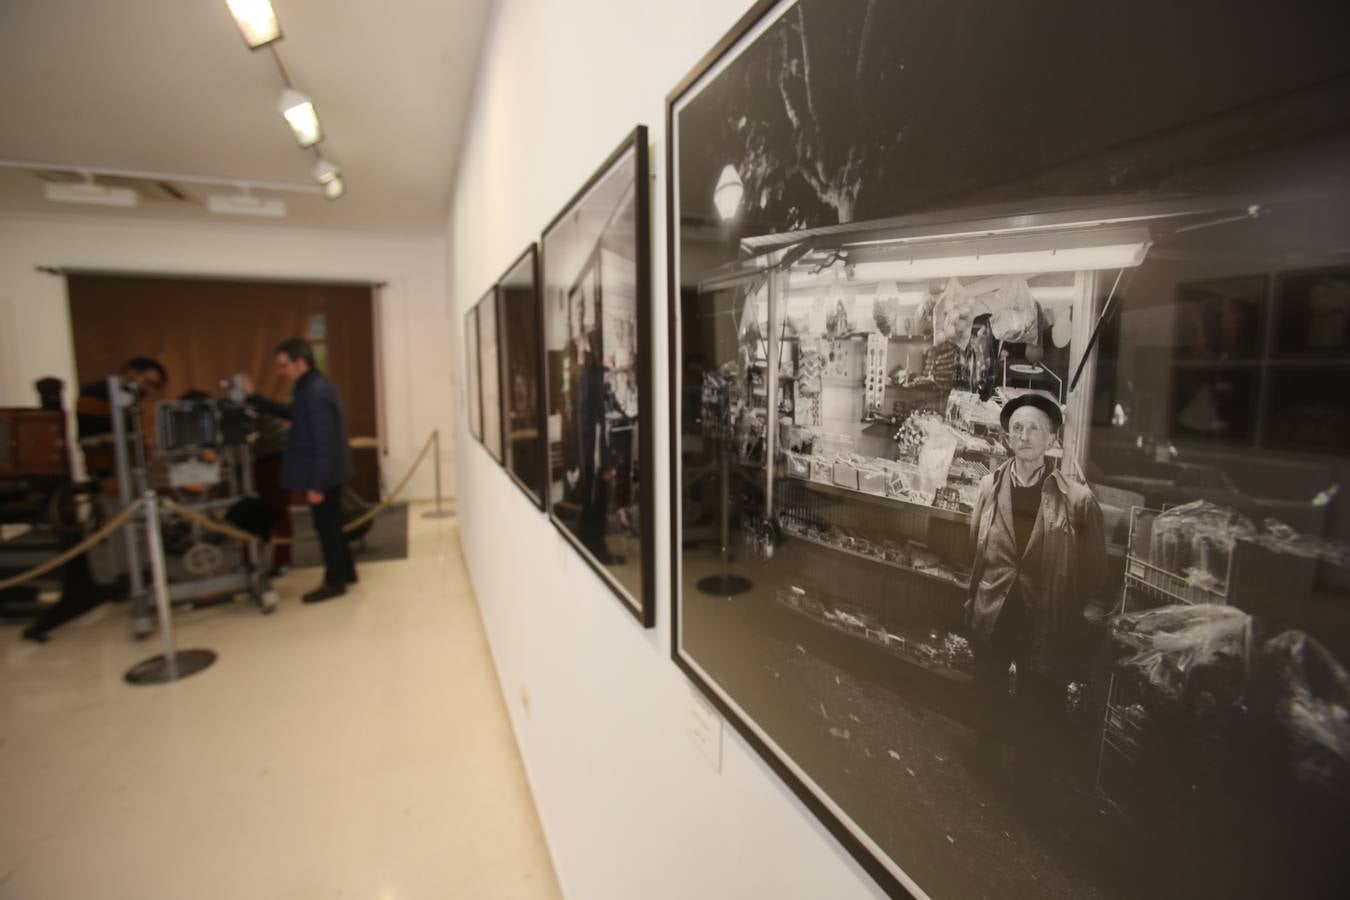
[66,274,379,499]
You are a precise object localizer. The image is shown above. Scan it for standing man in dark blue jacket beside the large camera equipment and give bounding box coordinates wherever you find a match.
[267,337,356,603]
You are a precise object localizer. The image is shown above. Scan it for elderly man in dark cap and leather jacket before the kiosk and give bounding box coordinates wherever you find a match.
[967,394,1106,770]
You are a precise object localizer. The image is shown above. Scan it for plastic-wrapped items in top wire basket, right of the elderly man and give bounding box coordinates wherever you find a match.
[1149,501,1257,592]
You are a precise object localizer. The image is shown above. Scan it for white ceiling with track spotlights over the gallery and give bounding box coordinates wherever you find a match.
[0,0,491,233]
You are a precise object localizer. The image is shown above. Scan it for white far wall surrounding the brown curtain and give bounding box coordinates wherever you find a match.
[0,215,459,498]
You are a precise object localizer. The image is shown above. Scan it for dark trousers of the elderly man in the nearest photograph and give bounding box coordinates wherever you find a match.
[975,595,1065,762]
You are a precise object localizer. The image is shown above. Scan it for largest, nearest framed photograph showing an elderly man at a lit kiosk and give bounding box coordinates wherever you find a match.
[666,0,1350,900]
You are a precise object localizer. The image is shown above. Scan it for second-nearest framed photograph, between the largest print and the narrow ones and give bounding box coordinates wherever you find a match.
[541,125,656,627]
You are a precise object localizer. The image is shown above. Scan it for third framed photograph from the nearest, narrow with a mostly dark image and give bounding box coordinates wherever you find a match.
[497,244,548,509]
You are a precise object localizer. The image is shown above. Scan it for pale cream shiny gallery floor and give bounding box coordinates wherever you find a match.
[0,507,560,900]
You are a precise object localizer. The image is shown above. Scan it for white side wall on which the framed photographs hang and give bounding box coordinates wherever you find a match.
[447,0,884,900]
